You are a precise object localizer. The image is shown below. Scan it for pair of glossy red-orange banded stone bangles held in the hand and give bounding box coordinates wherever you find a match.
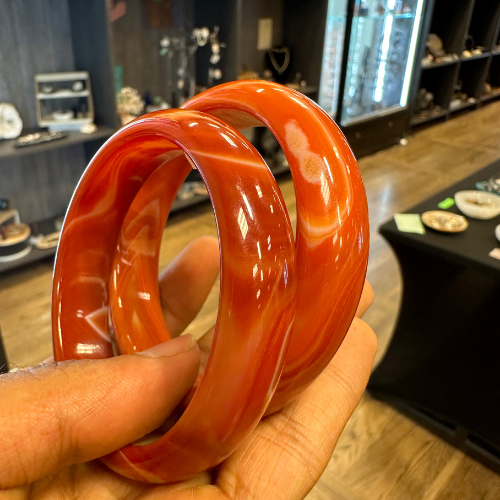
[52,81,369,483]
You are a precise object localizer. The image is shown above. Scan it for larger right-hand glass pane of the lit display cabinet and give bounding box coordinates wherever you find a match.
[338,0,424,126]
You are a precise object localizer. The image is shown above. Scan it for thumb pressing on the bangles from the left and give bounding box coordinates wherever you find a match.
[0,335,200,489]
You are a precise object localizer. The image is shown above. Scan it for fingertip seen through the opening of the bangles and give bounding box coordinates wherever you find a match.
[159,236,220,337]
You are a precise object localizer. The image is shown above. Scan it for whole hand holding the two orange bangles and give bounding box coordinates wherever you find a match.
[0,237,377,500]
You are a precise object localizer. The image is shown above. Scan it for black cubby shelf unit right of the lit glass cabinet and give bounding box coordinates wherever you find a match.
[409,0,500,129]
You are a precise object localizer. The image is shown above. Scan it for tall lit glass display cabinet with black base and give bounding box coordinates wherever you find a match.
[318,0,426,156]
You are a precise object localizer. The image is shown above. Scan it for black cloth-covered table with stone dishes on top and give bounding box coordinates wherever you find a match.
[368,162,500,472]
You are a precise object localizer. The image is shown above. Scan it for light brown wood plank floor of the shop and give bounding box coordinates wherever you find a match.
[0,102,500,500]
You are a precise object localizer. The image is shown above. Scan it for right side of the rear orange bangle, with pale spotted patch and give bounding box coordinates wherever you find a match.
[184,80,369,414]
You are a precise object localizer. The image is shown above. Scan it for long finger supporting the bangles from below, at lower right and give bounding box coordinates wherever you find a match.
[217,318,377,500]
